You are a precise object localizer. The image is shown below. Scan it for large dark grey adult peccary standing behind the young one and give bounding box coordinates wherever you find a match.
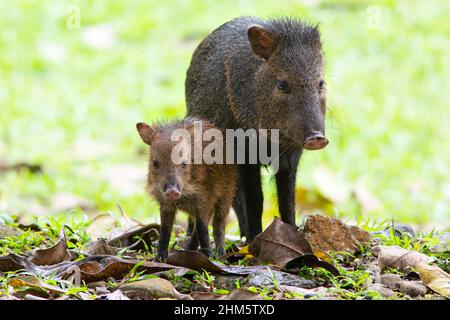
[186,17,328,240]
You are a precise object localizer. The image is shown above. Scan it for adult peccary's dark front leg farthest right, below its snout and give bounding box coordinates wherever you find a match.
[276,150,301,226]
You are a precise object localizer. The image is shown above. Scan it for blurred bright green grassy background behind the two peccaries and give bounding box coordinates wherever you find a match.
[0,0,450,231]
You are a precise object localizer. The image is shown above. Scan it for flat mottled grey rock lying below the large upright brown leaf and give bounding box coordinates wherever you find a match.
[246,268,318,289]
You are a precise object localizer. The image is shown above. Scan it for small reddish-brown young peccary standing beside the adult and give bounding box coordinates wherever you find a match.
[137,118,237,260]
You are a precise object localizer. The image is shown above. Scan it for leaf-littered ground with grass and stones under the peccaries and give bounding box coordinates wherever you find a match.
[0,211,450,300]
